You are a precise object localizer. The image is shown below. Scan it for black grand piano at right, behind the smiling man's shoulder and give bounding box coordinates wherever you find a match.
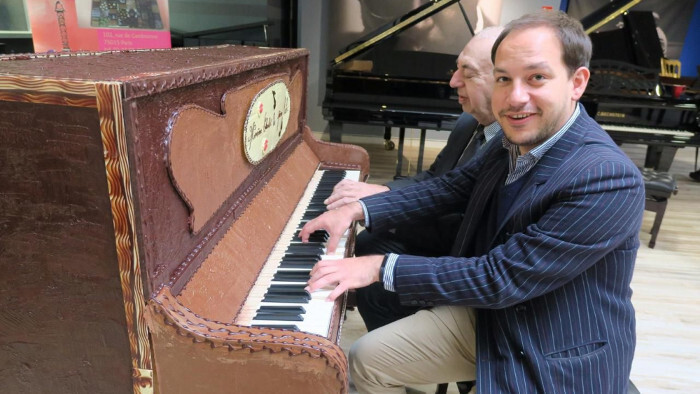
[581,0,700,171]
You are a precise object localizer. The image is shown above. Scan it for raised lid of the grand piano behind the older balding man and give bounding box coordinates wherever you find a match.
[330,0,473,67]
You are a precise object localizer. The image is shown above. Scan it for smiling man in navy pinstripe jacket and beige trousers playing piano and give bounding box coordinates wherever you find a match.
[302,12,644,393]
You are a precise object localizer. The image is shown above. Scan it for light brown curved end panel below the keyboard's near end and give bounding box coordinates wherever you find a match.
[147,287,348,394]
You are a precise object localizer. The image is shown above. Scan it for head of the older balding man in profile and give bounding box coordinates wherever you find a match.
[450,36,495,125]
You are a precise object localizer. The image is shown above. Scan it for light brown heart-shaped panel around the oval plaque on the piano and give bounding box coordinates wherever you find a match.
[165,72,301,234]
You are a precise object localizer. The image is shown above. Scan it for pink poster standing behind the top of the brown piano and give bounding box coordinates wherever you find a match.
[27,0,170,53]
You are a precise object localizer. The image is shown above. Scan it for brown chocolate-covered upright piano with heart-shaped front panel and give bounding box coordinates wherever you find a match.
[0,46,369,393]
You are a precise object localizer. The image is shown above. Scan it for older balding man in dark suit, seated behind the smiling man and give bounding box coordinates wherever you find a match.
[326,26,503,331]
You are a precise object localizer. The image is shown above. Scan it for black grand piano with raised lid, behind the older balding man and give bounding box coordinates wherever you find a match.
[323,0,474,176]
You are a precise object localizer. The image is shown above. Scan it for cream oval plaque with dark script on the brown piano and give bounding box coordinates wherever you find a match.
[243,81,289,164]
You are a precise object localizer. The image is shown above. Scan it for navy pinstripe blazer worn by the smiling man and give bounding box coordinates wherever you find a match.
[363,108,644,394]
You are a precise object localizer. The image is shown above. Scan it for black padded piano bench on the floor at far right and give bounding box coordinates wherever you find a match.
[640,168,678,248]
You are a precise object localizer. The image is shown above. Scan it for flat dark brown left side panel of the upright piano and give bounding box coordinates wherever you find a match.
[0,97,133,393]
